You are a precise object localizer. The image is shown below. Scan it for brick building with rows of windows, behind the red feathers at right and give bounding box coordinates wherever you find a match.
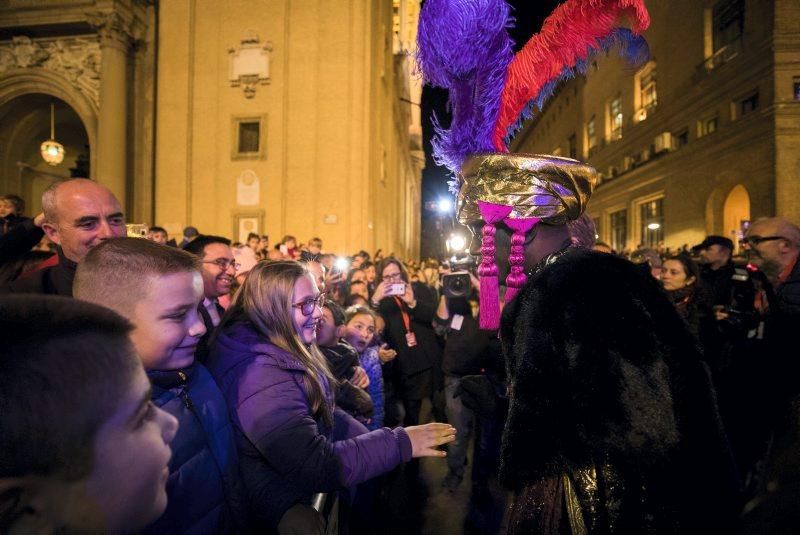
[513,0,800,251]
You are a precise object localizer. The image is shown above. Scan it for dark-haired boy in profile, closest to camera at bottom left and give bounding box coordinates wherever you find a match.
[0,295,178,534]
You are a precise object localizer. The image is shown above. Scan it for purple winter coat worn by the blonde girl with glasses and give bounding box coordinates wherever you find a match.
[207,322,411,529]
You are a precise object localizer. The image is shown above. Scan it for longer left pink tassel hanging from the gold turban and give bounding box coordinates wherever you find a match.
[478,201,511,330]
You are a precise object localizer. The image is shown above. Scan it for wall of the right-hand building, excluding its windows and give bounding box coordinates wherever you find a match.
[515,0,800,253]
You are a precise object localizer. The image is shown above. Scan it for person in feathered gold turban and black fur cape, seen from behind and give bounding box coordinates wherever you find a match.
[418,0,737,534]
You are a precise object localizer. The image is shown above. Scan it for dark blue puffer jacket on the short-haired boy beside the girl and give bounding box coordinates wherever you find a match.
[145,363,243,534]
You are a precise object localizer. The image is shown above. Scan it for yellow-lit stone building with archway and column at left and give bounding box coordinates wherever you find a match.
[0,0,424,258]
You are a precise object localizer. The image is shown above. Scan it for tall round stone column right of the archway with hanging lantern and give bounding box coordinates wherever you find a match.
[89,12,132,214]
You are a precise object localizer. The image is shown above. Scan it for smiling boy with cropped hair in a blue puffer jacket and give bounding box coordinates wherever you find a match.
[73,238,239,533]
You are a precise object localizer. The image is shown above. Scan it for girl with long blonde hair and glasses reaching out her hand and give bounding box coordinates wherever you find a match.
[208,261,455,533]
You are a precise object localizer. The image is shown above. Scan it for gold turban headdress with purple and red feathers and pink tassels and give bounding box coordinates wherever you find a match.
[417,0,650,329]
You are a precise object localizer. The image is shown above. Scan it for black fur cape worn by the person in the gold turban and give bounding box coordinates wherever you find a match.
[500,250,738,533]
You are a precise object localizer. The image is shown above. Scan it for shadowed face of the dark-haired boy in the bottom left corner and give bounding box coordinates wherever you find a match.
[85,369,178,533]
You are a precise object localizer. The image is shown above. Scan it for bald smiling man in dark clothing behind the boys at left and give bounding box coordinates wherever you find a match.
[4,178,127,297]
